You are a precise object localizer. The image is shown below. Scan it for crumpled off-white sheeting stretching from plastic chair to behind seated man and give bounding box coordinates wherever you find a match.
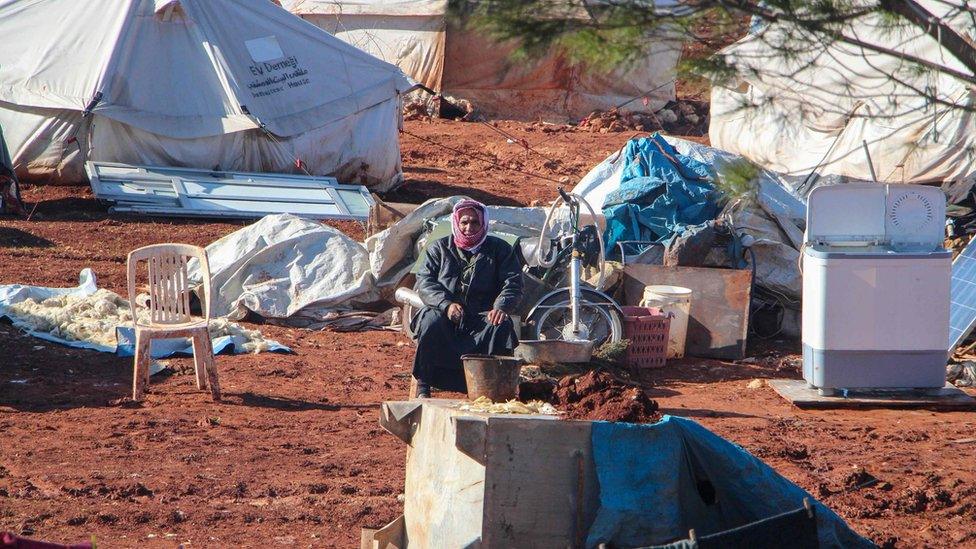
[190,201,568,322]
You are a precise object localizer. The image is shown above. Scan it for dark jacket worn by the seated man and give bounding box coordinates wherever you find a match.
[415,235,522,314]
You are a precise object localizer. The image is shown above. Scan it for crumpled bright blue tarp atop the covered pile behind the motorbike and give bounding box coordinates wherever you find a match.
[603,134,721,250]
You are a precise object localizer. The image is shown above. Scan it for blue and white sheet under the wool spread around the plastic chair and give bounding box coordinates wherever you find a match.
[0,268,291,358]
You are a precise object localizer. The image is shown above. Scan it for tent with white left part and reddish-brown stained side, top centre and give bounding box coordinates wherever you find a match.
[282,0,681,120]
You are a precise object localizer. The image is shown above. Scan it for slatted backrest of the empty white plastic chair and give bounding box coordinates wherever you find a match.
[128,244,210,326]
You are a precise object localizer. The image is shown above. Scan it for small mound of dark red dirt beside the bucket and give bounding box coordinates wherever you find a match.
[554,370,661,423]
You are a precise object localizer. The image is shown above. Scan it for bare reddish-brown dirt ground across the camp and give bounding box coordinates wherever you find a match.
[0,121,976,547]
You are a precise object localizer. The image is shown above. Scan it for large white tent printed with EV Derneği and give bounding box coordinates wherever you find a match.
[0,0,410,190]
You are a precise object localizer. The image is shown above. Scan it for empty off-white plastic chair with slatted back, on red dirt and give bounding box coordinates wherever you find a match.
[128,244,220,401]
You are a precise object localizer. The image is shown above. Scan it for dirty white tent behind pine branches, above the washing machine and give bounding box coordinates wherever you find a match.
[709,0,976,187]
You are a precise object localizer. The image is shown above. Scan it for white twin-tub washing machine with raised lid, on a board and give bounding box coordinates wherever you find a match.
[802,184,952,393]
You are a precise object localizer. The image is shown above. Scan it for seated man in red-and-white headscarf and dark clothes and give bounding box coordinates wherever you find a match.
[411,200,522,397]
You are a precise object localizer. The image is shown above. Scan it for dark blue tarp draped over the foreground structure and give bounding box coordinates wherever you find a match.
[586,416,874,547]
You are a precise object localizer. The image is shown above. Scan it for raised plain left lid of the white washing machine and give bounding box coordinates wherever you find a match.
[805,183,886,246]
